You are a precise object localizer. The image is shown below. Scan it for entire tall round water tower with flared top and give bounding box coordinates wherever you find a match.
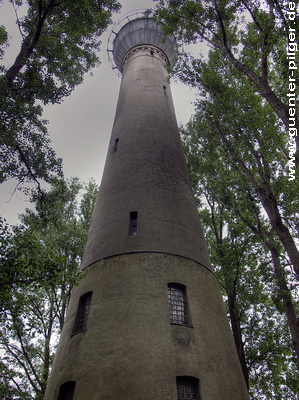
[45,10,248,400]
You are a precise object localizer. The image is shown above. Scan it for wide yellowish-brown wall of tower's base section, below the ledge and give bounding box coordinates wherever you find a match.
[45,254,248,400]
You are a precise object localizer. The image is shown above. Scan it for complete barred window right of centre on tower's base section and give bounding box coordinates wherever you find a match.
[168,283,188,325]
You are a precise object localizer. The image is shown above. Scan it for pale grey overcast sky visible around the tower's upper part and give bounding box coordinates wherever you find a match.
[0,0,200,223]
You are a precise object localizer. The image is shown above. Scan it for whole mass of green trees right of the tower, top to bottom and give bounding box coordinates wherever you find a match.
[164,0,299,390]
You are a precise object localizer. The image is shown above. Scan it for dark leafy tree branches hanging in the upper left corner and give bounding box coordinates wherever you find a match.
[0,0,120,190]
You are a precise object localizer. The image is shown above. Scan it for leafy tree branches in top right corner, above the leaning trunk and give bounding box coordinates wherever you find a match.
[155,0,299,165]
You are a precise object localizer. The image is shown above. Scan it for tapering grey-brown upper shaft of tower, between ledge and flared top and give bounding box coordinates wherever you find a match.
[82,46,211,268]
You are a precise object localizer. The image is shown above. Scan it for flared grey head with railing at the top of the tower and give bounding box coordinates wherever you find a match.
[108,11,177,73]
